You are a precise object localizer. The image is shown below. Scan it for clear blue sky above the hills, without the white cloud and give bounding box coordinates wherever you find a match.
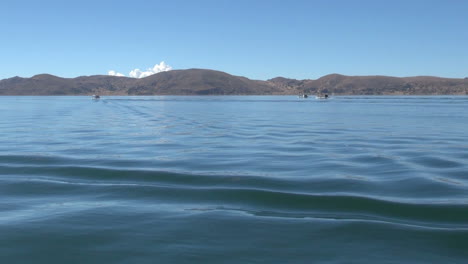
[0,0,468,79]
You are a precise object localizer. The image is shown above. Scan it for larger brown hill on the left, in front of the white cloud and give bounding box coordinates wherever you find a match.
[0,69,285,95]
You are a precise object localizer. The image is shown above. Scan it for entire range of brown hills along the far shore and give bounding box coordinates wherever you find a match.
[0,69,468,95]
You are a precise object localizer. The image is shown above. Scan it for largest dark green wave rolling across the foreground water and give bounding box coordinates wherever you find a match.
[0,166,468,228]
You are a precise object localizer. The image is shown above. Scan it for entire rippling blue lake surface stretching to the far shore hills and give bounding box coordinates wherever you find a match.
[0,96,468,263]
